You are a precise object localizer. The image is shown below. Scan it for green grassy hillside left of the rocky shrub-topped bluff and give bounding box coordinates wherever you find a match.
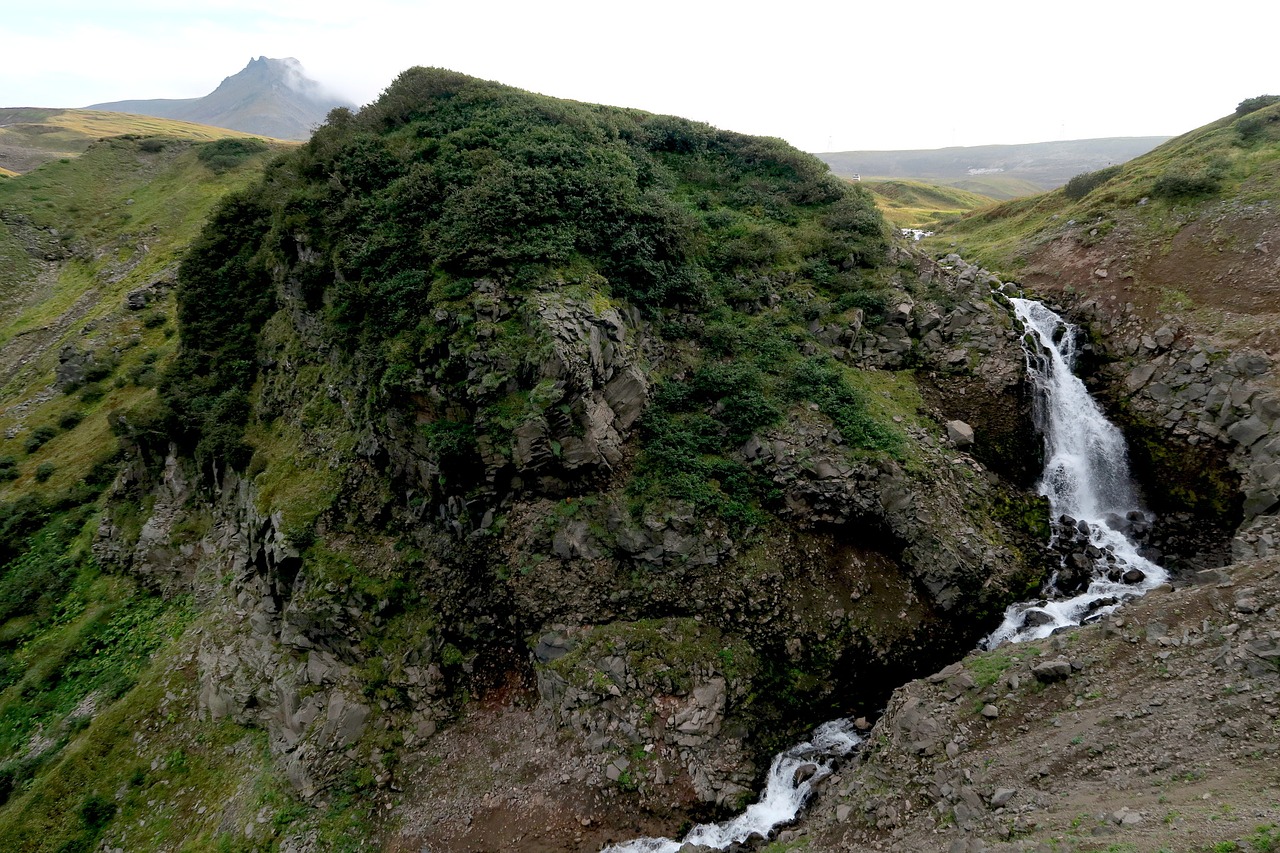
[0,131,299,850]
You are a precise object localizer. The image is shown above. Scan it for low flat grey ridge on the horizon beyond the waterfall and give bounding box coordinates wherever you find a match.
[817,136,1169,199]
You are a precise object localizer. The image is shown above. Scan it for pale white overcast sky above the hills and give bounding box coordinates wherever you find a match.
[0,0,1280,151]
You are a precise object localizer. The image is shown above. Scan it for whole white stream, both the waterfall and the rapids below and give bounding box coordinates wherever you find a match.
[602,298,1169,853]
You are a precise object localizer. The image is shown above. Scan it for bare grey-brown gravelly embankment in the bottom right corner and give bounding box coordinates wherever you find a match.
[787,548,1280,853]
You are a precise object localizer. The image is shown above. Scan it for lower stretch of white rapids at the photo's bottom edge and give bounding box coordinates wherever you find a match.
[603,720,863,853]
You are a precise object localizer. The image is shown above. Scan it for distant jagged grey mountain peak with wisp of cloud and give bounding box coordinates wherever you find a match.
[86,56,355,140]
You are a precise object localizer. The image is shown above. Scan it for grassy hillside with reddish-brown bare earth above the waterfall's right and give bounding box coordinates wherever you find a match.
[938,99,1280,338]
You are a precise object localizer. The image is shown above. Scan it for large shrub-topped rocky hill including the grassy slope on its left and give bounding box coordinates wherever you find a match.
[0,69,1059,850]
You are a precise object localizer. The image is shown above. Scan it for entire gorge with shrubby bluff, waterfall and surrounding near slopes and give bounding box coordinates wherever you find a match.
[0,68,1280,853]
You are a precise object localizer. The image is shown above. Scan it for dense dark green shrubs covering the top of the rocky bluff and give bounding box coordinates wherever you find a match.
[161,68,887,512]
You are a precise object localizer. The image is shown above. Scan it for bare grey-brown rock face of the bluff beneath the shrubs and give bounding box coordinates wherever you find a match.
[100,240,1059,807]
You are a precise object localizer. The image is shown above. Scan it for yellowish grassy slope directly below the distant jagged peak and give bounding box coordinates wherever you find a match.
[0,108,282,173]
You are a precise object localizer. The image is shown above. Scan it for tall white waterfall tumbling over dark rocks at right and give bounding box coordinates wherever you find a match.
[983,298,1169,648]
